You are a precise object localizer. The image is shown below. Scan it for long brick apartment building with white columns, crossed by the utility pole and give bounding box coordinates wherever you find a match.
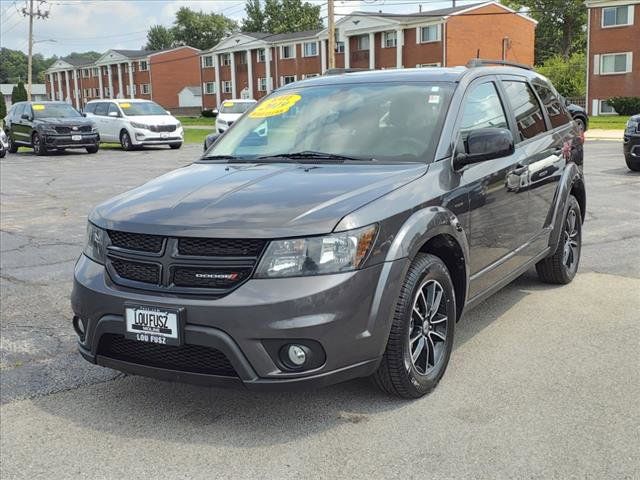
[200,2,536,109]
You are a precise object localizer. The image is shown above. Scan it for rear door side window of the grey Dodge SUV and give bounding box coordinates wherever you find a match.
[502,80,546,140]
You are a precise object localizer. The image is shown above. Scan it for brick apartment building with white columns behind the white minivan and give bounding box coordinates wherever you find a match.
[45,47,201,109]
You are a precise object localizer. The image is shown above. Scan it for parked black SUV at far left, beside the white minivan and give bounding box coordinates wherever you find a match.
[4,102,100,155]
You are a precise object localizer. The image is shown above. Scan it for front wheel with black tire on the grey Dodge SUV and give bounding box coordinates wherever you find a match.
[372,253,456,398]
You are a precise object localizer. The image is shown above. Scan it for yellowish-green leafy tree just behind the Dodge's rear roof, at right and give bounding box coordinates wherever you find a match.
[536,53,587,97]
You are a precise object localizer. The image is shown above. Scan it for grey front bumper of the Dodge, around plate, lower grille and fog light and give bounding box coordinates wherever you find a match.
[71,255,408,389]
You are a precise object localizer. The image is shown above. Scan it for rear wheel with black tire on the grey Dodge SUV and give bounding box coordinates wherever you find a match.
[536,195,582,285]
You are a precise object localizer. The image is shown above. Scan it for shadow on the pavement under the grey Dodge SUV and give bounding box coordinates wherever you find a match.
[33,266,554,448]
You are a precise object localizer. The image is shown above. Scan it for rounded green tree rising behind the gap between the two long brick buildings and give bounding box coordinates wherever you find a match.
[171,7,238,50]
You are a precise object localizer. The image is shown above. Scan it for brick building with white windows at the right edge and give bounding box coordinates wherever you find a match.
[586,0,640,115]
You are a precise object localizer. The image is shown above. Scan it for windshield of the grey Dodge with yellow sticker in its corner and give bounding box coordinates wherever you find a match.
[205,82,453,161]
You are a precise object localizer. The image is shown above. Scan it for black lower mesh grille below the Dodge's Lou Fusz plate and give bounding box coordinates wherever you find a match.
[98,333,238,377]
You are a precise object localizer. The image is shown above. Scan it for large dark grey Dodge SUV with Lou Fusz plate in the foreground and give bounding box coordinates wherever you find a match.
[72,63,585,398]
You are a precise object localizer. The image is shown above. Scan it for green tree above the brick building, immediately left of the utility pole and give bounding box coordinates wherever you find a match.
[264,0,322,33]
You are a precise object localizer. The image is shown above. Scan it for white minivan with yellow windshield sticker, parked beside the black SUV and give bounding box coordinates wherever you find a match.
[83,99,184,150]
